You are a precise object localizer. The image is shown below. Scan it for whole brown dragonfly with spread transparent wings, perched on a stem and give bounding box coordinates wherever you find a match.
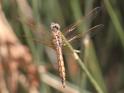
[21,7,103,88]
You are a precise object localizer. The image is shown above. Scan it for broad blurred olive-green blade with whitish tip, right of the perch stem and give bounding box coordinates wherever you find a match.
[83,35,107,93]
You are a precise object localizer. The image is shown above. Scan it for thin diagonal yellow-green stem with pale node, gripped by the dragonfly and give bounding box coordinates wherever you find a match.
[62,35,104,93]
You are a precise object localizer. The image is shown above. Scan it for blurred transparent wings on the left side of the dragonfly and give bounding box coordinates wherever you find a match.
[19,25,54,48]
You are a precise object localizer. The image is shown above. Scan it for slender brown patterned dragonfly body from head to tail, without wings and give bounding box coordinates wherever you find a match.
[51,23,65,88]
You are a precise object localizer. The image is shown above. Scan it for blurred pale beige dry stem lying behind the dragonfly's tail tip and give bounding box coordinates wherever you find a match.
[38,66,79,93]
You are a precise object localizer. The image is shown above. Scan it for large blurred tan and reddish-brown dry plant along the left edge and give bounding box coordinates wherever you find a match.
[0,4,40,93]
